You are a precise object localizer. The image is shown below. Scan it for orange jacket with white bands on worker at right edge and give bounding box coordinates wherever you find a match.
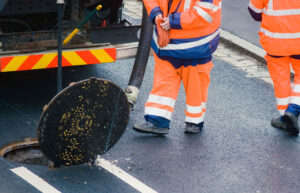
[249,0,300,56]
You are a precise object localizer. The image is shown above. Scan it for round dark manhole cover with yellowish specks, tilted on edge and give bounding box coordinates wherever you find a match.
[38,78,129,165]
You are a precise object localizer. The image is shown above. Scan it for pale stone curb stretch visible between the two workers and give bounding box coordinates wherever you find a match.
[220,29,267,65]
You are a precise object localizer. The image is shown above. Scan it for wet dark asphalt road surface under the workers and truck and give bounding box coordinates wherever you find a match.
[0,42,300,193]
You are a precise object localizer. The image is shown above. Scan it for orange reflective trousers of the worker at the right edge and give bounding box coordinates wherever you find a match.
[265,55,300,115]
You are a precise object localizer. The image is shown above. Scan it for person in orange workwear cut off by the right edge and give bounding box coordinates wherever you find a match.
[248,0,300,135]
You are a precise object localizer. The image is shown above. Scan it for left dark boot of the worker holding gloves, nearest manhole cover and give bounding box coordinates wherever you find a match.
[132,121,169,135]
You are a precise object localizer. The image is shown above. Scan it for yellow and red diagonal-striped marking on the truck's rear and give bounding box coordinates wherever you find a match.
[0,48,116,72]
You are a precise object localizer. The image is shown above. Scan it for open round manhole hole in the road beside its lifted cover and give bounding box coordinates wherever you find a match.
[0,138,49,166]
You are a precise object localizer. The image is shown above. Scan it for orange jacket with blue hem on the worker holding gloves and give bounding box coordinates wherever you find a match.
[144,0,221,59]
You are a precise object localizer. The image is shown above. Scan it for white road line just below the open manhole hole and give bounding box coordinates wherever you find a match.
[10,167,61,193]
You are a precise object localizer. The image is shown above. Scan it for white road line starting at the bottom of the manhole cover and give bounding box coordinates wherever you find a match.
[96,156,157,193]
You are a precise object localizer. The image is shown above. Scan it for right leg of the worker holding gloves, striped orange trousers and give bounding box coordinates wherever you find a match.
[182,61,213,133]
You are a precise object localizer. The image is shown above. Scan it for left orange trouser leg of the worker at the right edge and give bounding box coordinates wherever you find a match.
[265,55,291,115]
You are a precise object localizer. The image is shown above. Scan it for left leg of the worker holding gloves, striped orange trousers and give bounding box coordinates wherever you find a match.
[133,54,181,134]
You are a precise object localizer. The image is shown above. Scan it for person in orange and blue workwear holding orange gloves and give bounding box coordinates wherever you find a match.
[133,0,221,135]
